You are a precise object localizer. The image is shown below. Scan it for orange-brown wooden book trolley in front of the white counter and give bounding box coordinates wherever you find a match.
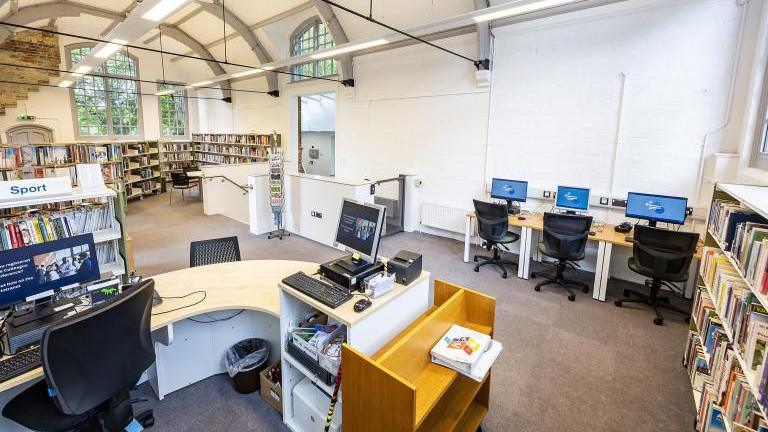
[342,280,496,432]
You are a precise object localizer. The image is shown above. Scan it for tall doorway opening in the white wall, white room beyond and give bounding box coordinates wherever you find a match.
[299,93,336,177]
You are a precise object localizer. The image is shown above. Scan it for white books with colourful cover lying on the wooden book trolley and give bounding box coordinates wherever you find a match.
[430,324,503,382]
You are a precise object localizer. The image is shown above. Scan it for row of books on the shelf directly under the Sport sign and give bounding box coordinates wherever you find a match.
[0,204,115,250]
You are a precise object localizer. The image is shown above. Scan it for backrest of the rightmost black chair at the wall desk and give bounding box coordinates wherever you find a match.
[632,225,699,282]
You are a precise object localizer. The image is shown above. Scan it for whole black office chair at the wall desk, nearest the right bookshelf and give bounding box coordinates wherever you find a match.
[615,225,699,325]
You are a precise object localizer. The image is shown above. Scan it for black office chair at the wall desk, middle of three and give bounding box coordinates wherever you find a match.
[531,213,592,301]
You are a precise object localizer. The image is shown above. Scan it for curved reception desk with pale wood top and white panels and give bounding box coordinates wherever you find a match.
[0,260,432,431]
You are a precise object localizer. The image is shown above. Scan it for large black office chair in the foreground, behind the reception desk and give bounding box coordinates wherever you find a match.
[3,279,155,432]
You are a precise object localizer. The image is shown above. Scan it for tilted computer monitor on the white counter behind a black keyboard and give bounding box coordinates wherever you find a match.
[335,198,387,270]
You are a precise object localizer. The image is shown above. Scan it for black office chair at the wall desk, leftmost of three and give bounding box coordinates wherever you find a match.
[473,200,520,279]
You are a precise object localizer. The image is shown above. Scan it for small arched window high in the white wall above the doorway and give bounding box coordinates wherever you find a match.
[291,19,337,81]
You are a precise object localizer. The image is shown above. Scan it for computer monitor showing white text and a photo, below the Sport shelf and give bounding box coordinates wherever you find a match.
[0,234,100,309]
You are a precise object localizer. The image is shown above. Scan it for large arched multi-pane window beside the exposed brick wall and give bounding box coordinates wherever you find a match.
[67,44,141,138]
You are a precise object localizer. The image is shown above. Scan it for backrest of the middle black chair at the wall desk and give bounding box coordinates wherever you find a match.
[543,213,592,260]
